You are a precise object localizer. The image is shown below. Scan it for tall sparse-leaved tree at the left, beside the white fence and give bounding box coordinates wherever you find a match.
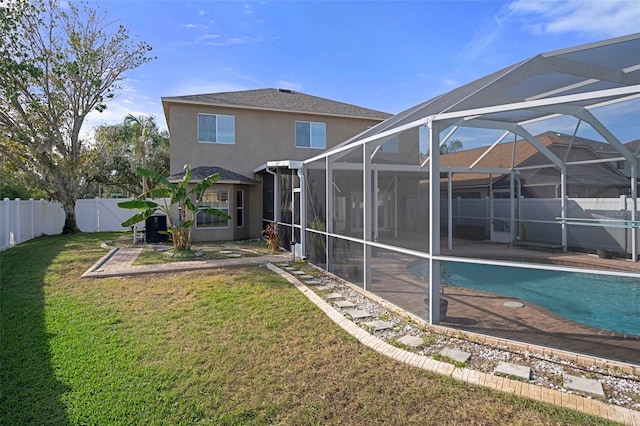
[0,0,153,233]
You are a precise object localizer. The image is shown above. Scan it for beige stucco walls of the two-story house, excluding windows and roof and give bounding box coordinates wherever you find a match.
[169,100,379,241]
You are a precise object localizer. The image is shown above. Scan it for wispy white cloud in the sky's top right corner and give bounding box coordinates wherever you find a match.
[507,0,640,37]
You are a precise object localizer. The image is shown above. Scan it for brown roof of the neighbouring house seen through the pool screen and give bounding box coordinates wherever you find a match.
[440,132,629,186]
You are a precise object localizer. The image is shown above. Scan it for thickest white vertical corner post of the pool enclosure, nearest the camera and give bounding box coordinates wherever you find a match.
[427,120,440,324]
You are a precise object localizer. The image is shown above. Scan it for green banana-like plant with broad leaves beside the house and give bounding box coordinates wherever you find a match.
[118,165,231,250]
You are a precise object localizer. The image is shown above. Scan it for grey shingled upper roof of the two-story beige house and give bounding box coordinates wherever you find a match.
[162,89,391,122]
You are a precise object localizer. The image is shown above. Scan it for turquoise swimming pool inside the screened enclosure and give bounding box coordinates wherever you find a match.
[409,262,640,336]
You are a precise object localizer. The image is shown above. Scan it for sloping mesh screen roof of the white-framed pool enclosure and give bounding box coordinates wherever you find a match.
[334,33,640,153]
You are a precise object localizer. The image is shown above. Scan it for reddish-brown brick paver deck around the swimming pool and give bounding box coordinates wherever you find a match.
[369,241,640,374]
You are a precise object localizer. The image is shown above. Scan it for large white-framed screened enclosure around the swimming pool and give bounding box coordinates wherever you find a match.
[256,34,640,363]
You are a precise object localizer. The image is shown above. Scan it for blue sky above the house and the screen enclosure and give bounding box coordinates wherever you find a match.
[87,0,640,136]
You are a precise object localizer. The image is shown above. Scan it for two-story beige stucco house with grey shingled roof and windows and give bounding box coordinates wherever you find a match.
[162,89,390,241]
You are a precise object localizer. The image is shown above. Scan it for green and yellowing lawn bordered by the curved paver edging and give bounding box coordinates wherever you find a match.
[0,234,620,425]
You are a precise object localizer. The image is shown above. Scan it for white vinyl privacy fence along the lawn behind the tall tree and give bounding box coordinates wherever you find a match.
[0,198,168,251]
